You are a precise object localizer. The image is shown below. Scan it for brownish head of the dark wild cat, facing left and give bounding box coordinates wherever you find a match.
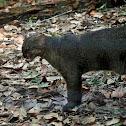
[22,34,45,60]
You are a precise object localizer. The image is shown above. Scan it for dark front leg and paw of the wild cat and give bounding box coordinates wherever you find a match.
[63,72,82,111]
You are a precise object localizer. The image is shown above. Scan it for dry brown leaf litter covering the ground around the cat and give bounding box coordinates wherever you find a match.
[0,1,126,126]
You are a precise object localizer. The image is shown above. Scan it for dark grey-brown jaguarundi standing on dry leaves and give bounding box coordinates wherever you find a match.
[22,26,126,111]
